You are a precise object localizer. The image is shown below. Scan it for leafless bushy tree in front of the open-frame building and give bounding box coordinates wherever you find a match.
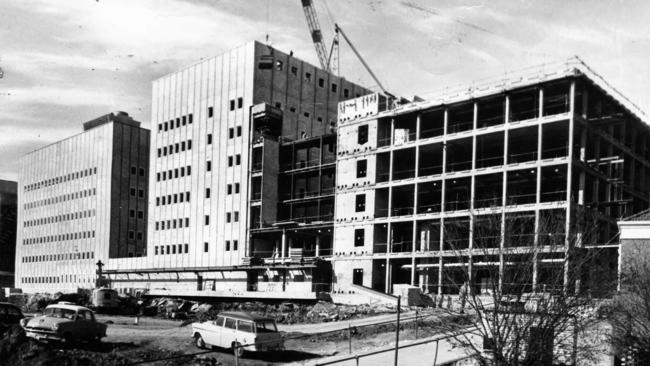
[436,210,601,366]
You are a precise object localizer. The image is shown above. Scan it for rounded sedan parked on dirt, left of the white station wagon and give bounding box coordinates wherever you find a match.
[21,303,106,343]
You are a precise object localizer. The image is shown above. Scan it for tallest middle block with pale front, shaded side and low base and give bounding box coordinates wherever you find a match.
[105,42,368,297]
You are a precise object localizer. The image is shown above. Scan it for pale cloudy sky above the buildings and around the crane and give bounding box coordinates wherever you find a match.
[0,0,650,180]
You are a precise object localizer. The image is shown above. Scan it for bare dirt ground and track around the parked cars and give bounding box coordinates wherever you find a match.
[1,314,466,366]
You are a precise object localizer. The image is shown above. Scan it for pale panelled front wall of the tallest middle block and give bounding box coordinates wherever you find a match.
[107,42,255,272]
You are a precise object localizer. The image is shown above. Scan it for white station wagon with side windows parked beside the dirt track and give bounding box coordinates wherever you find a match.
[192,312,284,357]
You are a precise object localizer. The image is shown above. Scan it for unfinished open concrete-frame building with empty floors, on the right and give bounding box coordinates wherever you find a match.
[332,61,650,293]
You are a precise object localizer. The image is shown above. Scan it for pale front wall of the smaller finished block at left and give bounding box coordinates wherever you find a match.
[16,123,113,293]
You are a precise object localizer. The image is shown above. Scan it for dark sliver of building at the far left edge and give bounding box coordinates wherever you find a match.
[0,180,18,287]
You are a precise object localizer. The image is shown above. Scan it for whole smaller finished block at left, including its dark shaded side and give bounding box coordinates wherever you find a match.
[15,112,149,293]
